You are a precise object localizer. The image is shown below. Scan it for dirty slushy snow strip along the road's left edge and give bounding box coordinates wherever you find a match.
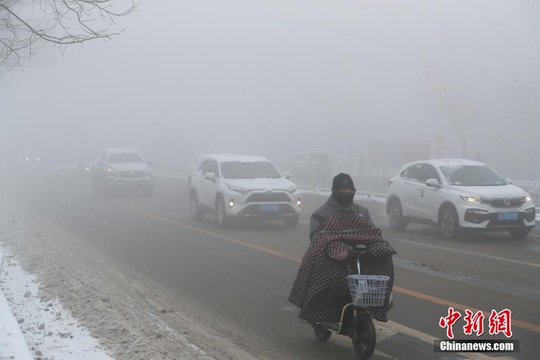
[0,198,272,360]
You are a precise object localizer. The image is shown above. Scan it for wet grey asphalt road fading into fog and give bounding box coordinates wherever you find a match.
[5,173,540,359]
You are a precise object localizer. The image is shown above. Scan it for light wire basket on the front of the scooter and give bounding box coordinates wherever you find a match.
[347,275,390,307]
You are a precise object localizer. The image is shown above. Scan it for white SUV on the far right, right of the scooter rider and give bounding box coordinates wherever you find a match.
[386,159,536,239]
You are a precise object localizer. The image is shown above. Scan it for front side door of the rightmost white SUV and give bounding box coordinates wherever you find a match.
[418,164,441,222]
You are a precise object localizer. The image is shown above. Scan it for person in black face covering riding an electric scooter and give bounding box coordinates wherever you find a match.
[289,173,396,359]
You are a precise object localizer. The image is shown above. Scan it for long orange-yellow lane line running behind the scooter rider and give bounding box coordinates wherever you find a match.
[101,202,540,334]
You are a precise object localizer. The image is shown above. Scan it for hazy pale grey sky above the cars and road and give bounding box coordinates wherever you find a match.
[0,0,540,172]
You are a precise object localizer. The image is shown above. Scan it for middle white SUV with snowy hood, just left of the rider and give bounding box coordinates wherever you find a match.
[190,154,301,227]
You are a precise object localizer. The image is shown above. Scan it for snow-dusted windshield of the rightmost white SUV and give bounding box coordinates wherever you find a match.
[441,165,507,186]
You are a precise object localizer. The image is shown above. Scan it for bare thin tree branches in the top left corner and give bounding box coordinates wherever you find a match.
[0,0,138,74]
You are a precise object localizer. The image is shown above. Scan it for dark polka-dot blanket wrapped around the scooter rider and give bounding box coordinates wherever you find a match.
[289,215,396,323]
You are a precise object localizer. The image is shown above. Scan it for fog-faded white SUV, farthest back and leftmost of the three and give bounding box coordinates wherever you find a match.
[92,148,154,196]
